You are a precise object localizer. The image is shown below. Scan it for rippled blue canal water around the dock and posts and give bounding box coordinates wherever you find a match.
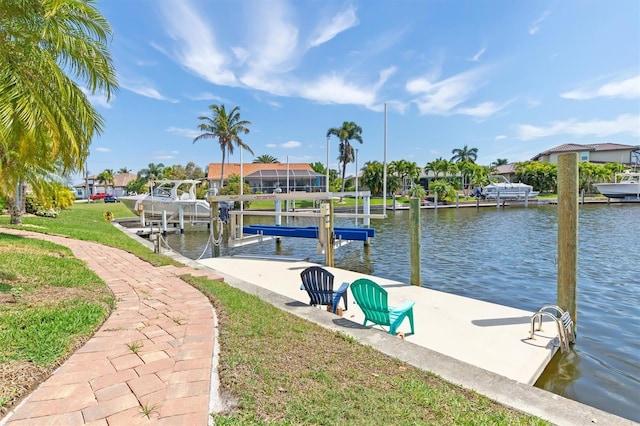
[168,204,640,422]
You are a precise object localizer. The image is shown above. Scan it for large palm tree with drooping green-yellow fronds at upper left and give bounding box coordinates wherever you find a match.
[0,0,117,224]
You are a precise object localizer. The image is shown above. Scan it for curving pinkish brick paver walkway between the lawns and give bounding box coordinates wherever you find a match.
[0,229,224,426]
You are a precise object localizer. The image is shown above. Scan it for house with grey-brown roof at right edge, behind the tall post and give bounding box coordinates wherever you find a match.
[532,143,640,166]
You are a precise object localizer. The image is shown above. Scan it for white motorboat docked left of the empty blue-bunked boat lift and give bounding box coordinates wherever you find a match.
[119,179,210,220]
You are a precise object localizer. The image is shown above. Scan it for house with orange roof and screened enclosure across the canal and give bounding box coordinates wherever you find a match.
[207,163,326,194]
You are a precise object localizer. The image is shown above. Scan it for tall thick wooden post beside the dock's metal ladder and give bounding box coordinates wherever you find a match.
[558,152,578,331]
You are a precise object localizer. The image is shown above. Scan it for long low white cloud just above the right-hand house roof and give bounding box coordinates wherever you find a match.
[516,114,640,140]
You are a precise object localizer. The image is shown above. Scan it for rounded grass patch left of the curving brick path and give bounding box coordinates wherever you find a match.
[0,234,115,414]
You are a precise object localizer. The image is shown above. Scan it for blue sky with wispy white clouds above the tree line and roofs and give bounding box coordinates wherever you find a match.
[82,0,640,181]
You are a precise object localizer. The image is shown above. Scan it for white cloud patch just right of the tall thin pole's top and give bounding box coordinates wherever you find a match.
[406,69,483,115]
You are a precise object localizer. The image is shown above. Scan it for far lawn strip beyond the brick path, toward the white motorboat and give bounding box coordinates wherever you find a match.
[0,202,178,266]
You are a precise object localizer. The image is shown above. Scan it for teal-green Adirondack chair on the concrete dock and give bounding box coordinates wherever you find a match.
[351,278,415,336]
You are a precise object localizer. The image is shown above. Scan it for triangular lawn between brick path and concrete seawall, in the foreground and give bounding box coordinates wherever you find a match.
[183,276,546,425]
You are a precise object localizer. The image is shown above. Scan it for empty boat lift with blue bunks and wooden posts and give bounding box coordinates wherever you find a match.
[207,191,385,266]
